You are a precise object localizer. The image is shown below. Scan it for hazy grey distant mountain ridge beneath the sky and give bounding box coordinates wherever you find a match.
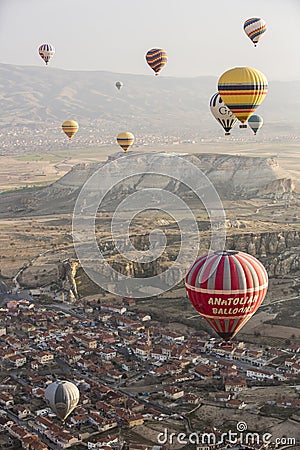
[0,64,300,135]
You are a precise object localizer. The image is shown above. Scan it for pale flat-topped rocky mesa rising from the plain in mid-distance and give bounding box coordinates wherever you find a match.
[0,151,295,217]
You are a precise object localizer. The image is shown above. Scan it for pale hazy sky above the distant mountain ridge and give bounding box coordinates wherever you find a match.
[0,0,300,80]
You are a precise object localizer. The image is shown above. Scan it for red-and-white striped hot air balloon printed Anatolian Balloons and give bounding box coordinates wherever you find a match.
[185,250,268,341]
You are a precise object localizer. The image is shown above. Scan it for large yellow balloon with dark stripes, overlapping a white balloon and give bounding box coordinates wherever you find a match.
[218,67,268,128]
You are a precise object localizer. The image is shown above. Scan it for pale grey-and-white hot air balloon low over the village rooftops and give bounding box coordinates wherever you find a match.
[45,381,79,421]
